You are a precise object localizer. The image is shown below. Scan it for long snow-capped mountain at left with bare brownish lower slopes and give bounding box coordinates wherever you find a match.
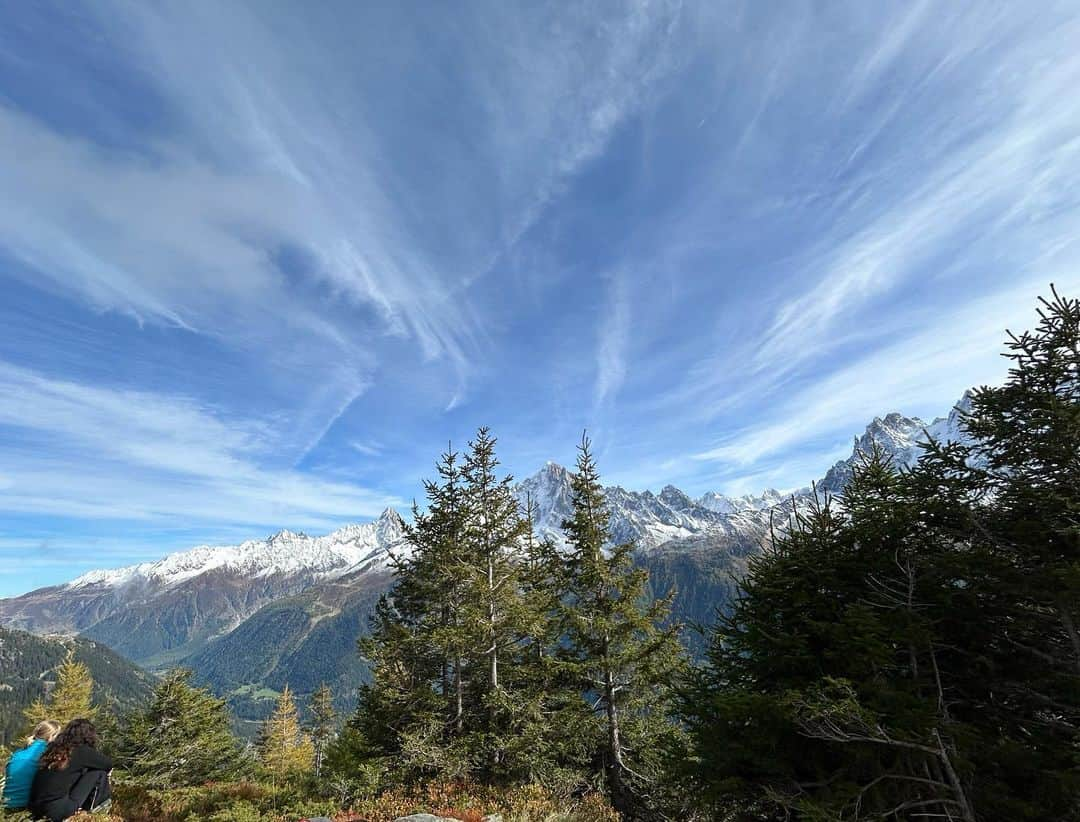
[0,509,404,665]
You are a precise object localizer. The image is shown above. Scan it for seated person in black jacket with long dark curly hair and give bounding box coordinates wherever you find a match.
[28,719,112,822]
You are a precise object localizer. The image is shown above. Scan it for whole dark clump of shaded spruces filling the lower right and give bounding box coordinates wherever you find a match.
[684,285,1080,822]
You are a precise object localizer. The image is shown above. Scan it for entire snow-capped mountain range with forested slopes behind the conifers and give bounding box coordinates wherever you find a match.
[0,394,969,722]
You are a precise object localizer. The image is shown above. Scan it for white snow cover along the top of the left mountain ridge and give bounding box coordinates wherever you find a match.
[64,509,404,589]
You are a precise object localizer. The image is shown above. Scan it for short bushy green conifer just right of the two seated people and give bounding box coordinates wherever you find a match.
[117,669,247,787]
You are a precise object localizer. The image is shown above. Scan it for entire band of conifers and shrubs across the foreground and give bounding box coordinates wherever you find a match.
[0,292,1080,822]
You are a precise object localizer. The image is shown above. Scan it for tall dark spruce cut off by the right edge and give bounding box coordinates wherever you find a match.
[933,286,1080,819]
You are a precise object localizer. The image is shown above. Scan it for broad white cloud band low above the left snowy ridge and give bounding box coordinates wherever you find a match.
[0,363,401,527]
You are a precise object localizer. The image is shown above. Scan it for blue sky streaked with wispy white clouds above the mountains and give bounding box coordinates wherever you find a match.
[0,0,1080,595]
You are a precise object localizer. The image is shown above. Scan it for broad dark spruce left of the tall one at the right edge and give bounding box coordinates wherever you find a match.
[684,449,974,822]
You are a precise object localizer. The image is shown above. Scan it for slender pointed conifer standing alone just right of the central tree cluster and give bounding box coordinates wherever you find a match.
[561,436,683,818]
